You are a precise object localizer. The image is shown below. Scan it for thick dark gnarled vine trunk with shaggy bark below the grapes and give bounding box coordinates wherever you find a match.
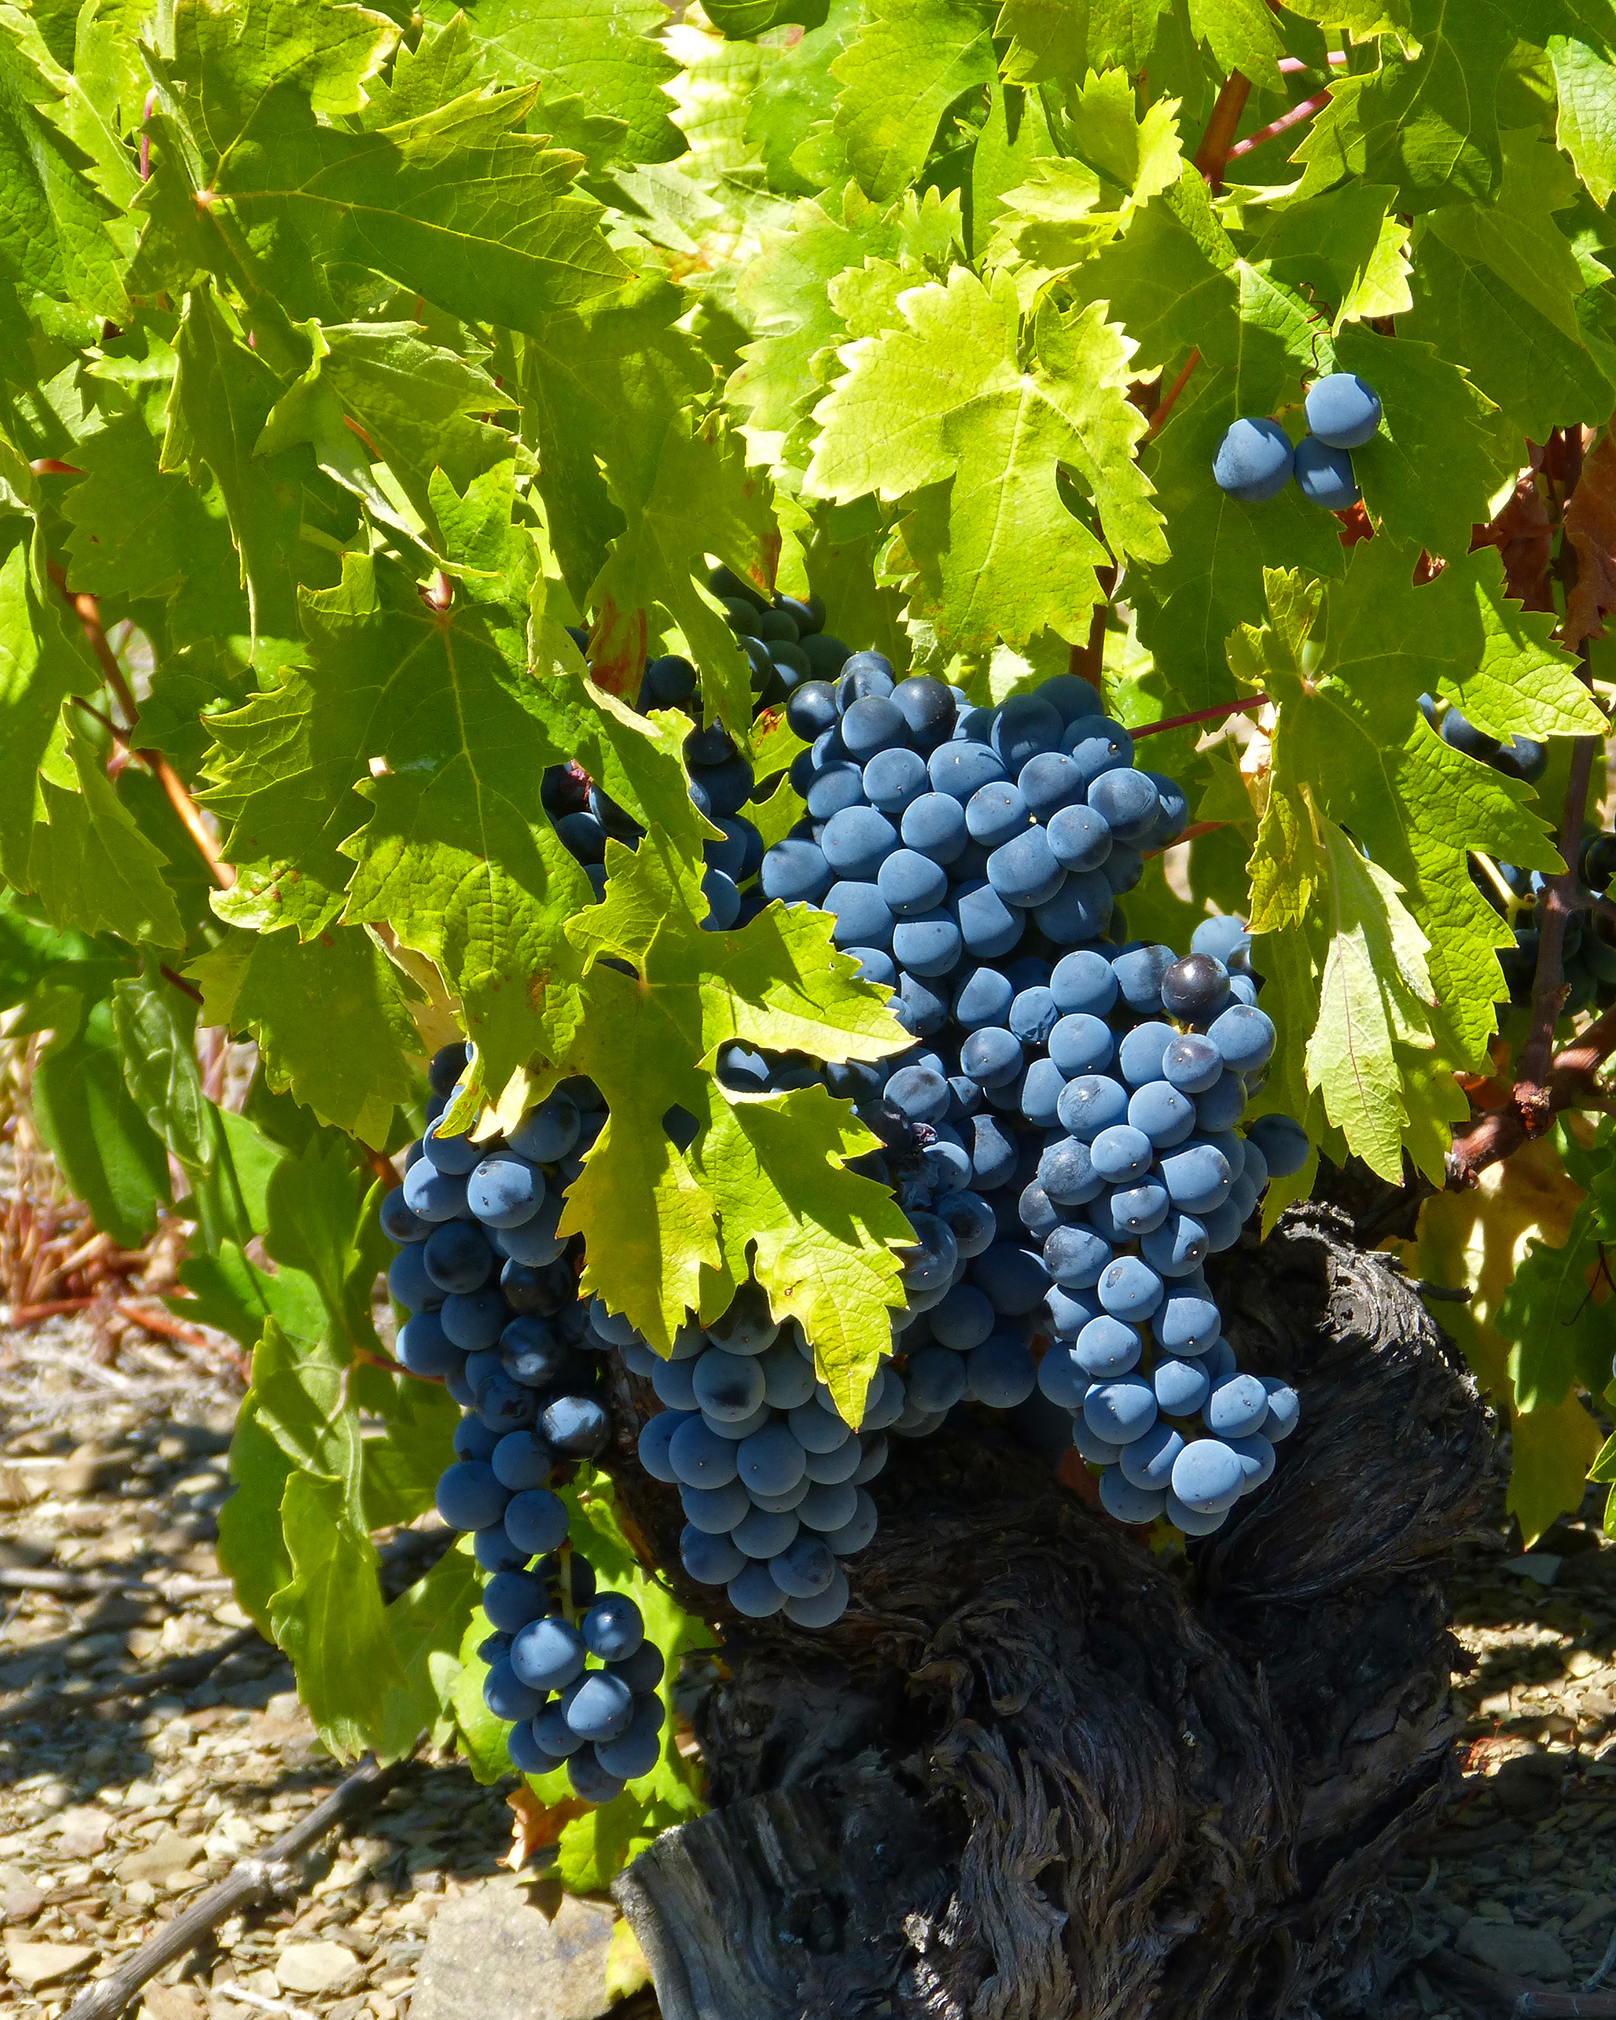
[616,1206,1491,2020]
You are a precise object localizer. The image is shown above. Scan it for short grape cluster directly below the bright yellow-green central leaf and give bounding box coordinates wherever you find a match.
[602,1283,876,1628]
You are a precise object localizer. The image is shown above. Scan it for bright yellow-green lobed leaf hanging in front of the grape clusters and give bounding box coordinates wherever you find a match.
[556,836,907,1394]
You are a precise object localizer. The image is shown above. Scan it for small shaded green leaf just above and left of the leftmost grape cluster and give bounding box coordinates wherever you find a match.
[188,925,420,1143]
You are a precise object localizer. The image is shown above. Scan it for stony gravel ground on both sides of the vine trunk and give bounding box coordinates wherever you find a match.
[0,1319,1616,2020]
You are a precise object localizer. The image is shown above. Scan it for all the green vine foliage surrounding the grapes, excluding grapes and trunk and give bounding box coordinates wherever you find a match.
[0,0,1616,1834]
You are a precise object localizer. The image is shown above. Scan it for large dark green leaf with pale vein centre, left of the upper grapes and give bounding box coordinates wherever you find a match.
[208,537,590,1089]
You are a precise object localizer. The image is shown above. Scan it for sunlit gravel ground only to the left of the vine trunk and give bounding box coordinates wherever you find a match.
[0,1319,549,2020]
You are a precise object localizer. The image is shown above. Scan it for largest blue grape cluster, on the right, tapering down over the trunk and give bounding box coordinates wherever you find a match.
[751,652,1309,1535]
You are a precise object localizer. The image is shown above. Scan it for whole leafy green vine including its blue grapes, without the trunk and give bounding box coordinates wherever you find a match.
[0,0,1616,1931]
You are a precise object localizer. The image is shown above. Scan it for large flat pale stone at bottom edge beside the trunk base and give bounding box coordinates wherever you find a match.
[410,1877,616,2020]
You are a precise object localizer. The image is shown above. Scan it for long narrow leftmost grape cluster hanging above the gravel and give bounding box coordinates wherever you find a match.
[382,1044,663,1802]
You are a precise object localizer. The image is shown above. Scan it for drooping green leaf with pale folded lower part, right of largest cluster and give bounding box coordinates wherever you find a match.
[1228,541,1566,1178]
